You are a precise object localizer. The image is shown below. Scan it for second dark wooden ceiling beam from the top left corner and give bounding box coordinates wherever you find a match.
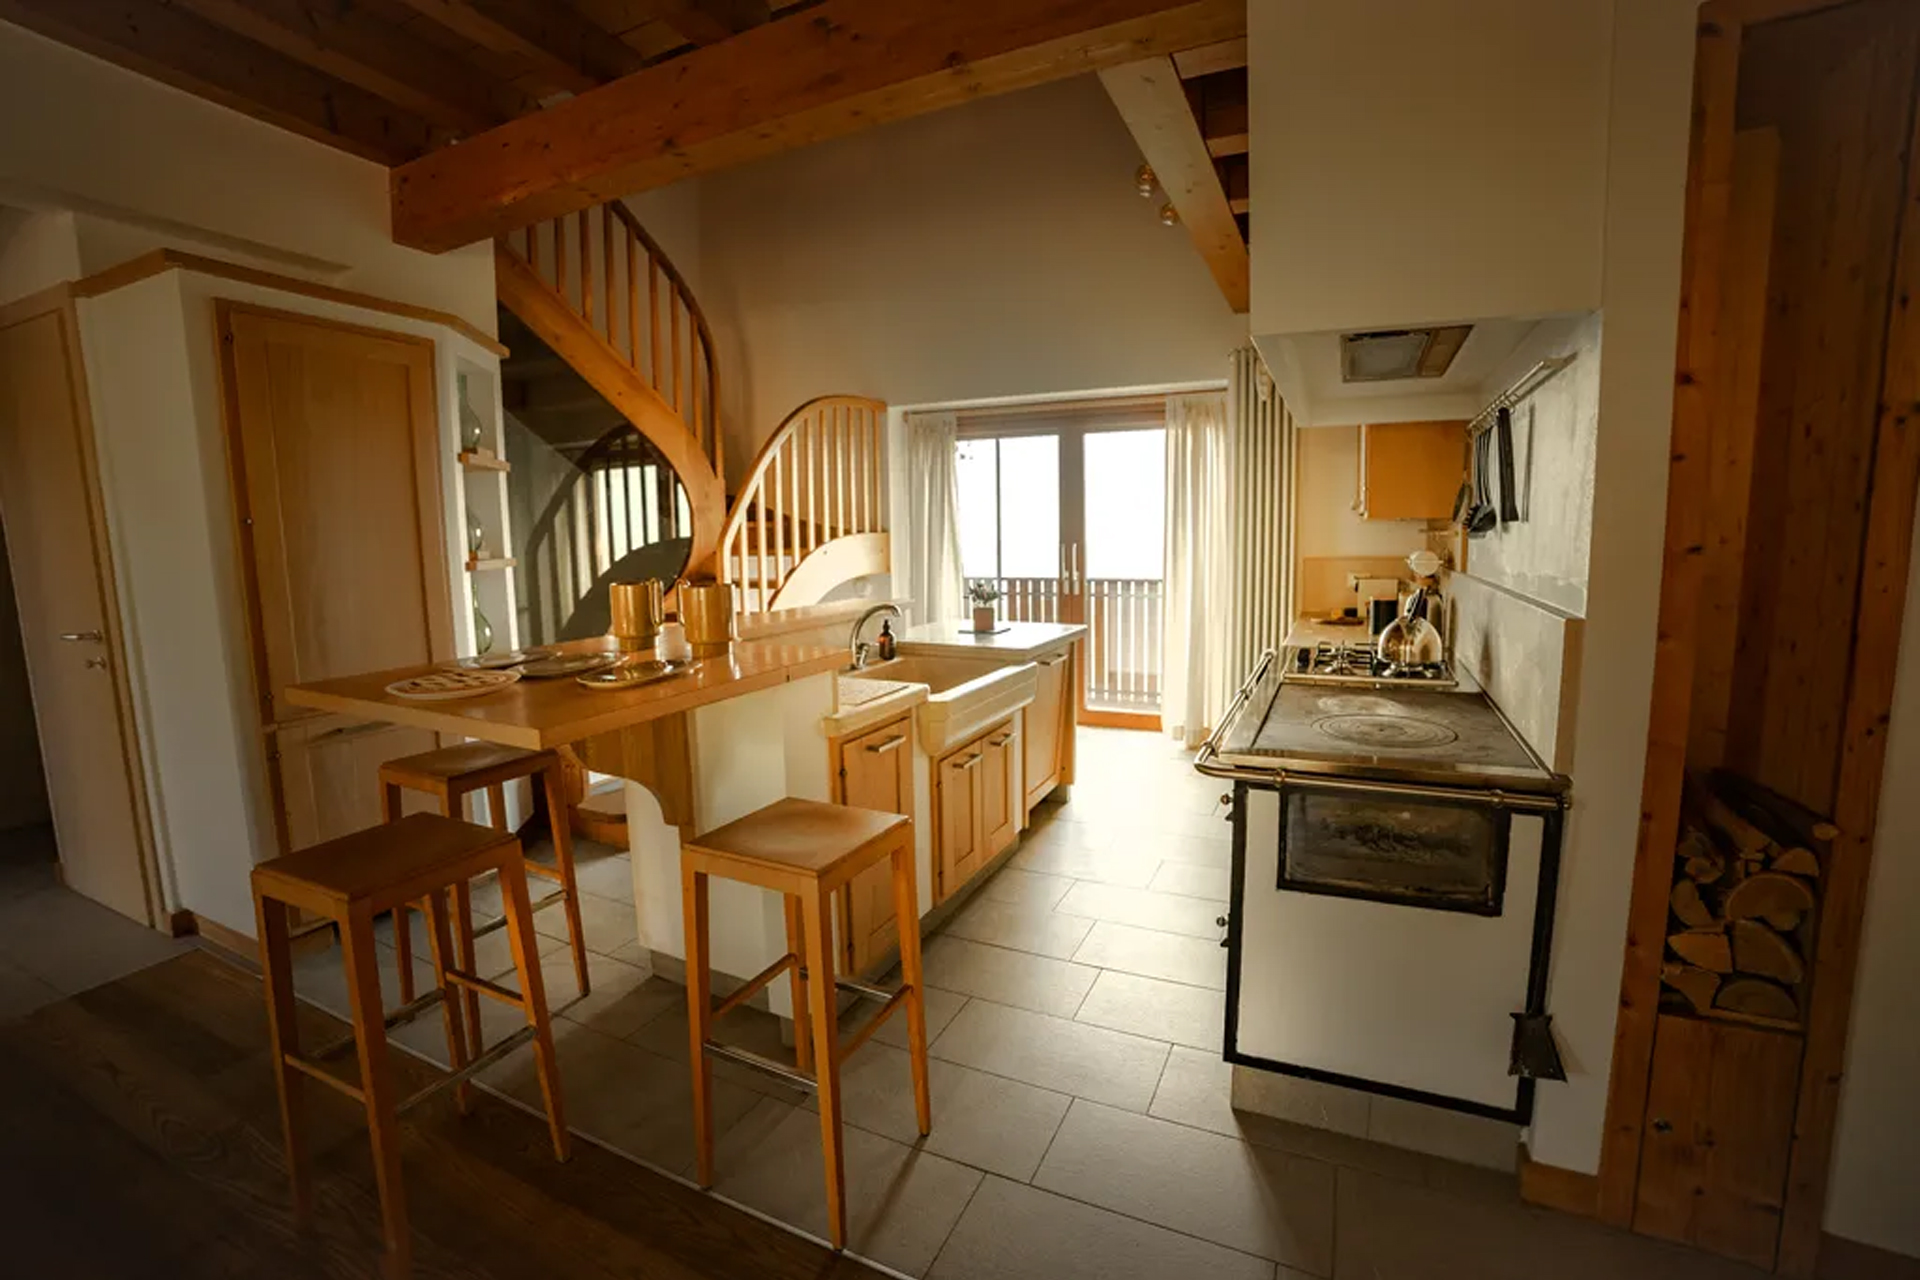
[162,0,534,132]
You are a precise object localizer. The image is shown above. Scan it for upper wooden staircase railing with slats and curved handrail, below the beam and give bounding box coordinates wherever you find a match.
[493,201,726,566]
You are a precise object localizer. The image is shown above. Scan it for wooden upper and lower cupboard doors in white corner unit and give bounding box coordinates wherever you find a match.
[219,303,453,848]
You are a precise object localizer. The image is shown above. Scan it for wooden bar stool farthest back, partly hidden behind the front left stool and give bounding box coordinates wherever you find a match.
[380,743,588,1028]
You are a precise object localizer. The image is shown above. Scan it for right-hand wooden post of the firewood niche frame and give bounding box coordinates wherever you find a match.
[1780,29,1920,1278]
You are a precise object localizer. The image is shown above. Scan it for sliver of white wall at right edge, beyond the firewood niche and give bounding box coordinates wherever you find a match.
[1826,528,1920,1257]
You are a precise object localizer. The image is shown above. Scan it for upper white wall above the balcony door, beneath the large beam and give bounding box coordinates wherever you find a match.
[636,77,1246,485]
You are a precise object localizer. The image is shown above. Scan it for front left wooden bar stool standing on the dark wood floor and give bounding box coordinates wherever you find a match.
[253,814,572,1276]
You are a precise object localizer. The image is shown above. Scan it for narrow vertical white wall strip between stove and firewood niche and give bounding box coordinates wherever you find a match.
[1528,0,1695,1173]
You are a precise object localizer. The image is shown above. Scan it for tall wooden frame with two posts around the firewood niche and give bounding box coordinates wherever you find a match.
[1597,0,1920,1280]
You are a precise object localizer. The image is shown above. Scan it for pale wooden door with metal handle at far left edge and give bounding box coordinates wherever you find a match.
[0,309,159,925]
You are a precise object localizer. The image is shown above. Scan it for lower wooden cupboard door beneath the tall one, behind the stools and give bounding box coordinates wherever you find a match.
[267,716,440,852]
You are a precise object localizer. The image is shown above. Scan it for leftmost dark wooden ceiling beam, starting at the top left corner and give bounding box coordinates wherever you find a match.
[0,0,434,165]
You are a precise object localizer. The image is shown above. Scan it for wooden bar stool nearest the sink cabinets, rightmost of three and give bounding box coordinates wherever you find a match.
[680,798,933,1249]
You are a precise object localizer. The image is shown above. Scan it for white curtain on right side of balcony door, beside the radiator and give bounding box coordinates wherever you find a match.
[1160,391,1233,747]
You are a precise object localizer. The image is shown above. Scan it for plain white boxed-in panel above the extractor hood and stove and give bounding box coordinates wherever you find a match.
[1248,0,1620,334]
